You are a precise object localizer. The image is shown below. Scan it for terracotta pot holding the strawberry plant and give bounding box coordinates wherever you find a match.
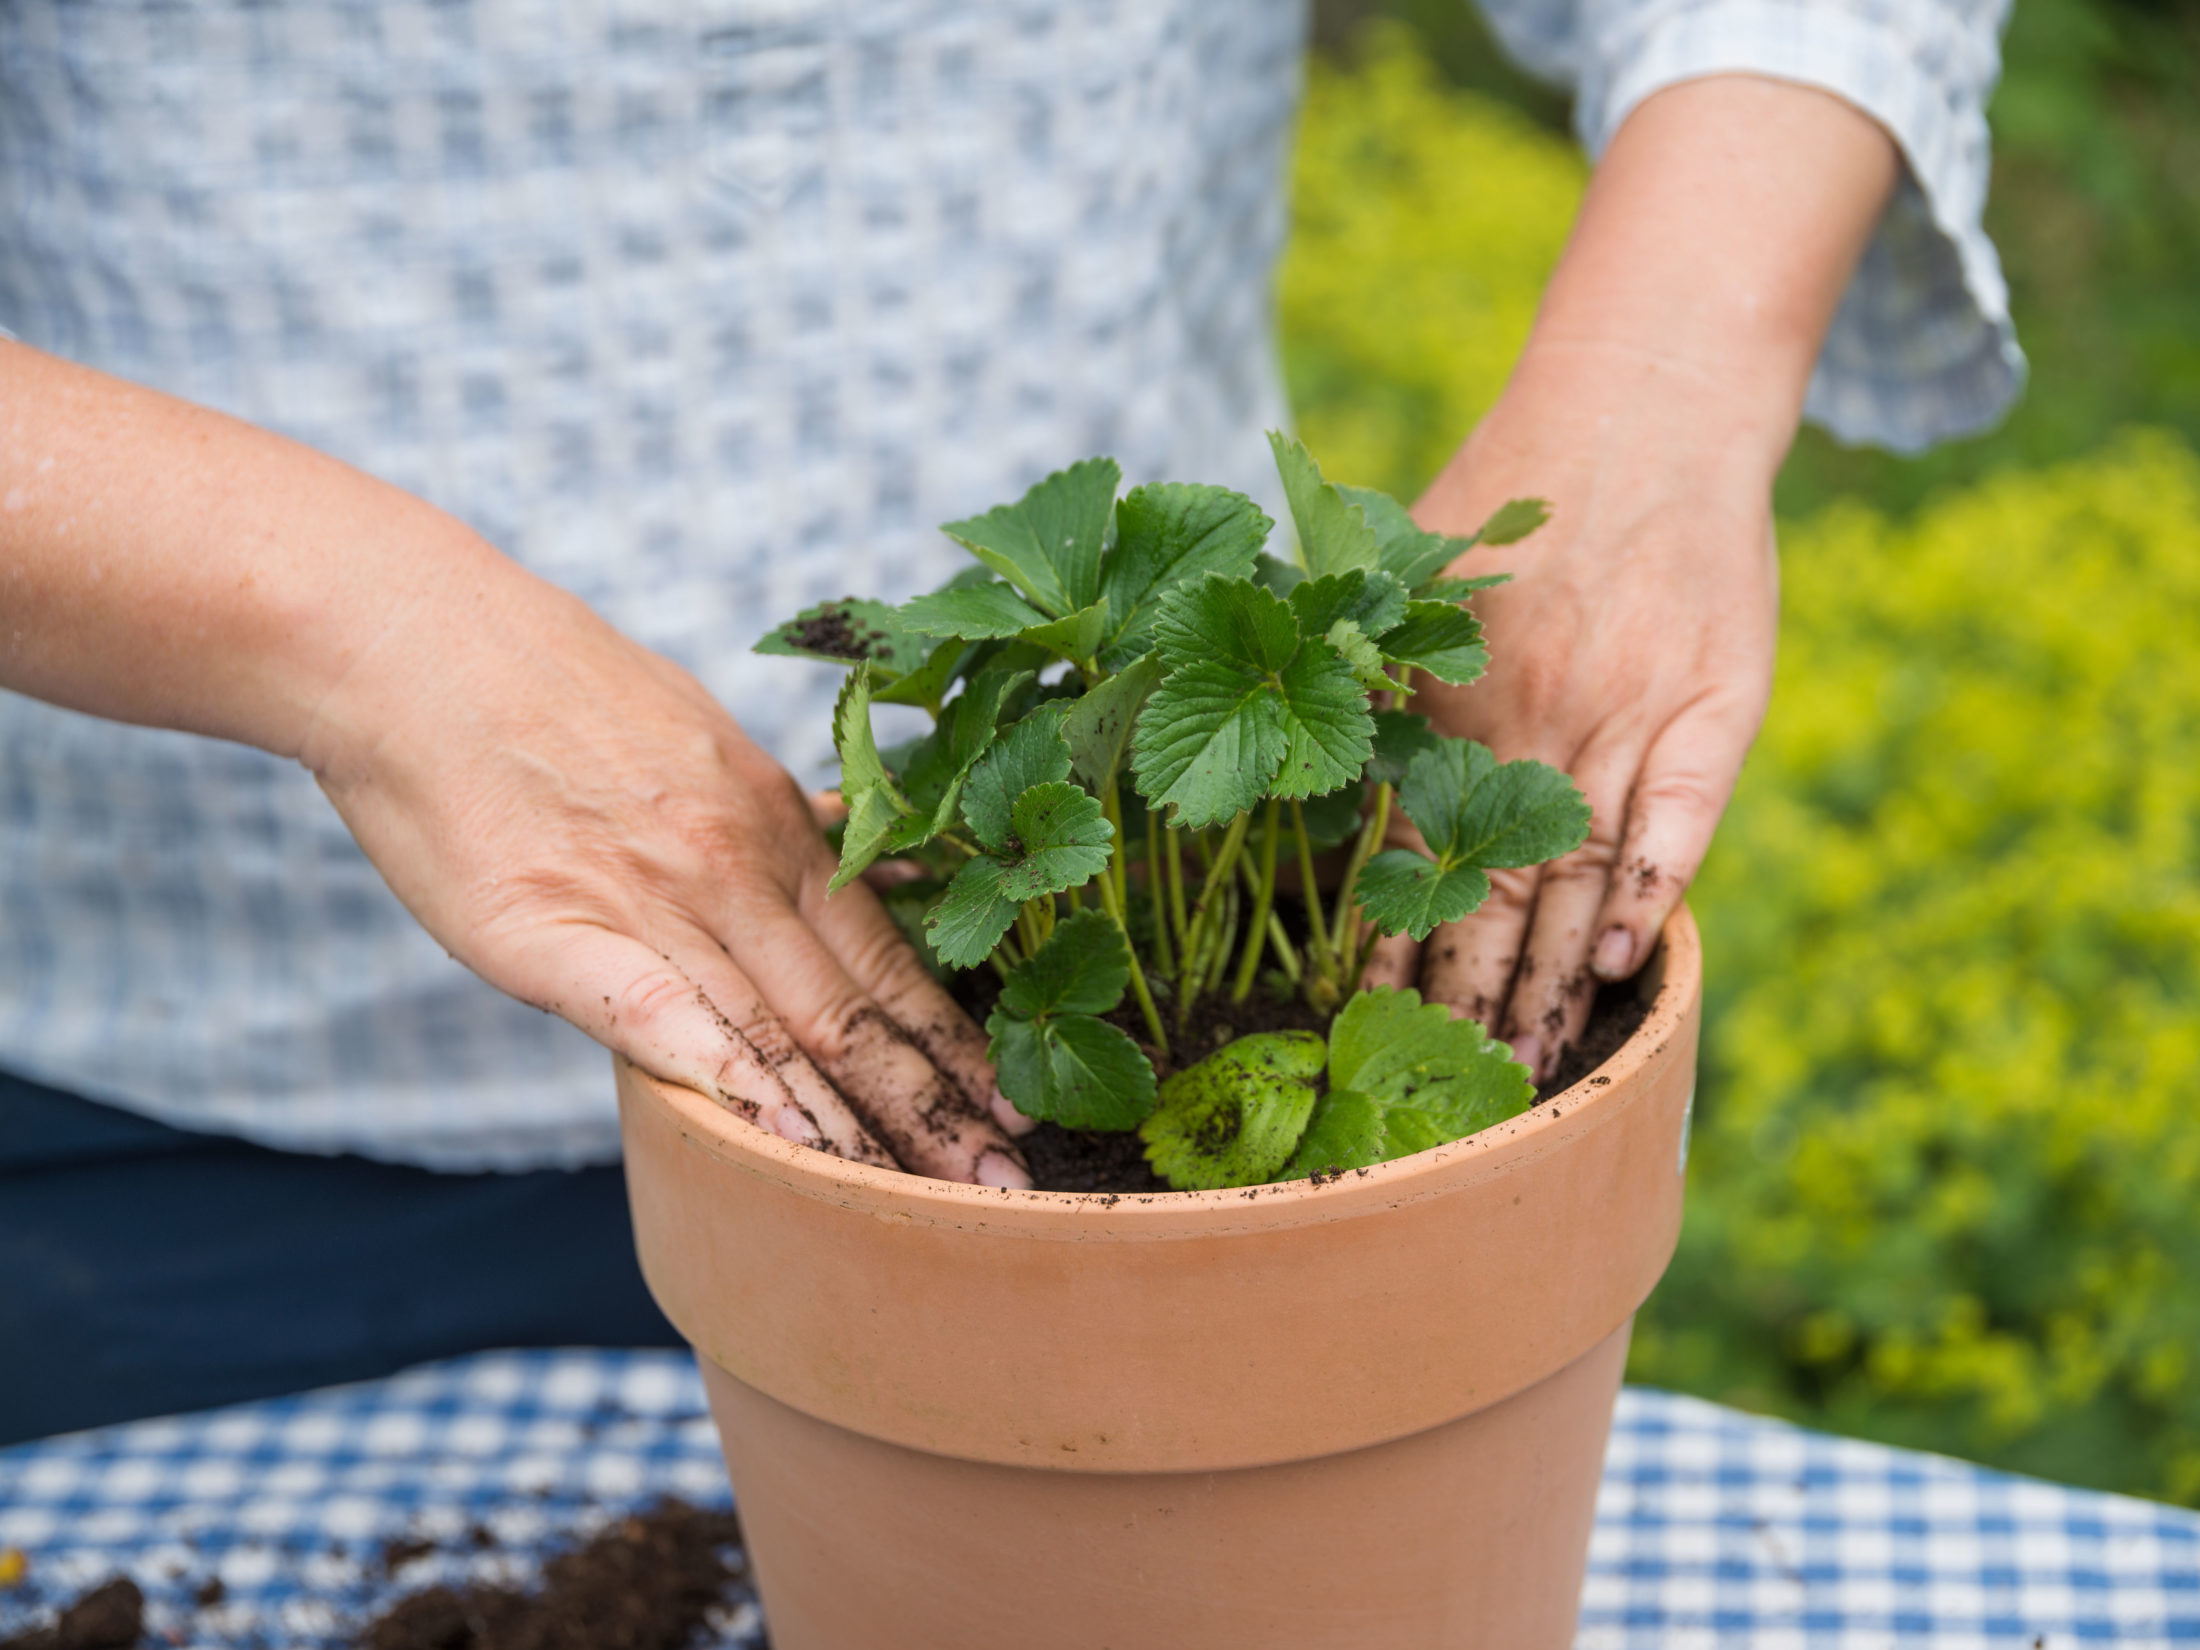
[618,911,1701,1650]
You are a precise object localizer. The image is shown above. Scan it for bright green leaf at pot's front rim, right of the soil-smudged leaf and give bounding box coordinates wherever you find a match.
[1287,986,1536,1177]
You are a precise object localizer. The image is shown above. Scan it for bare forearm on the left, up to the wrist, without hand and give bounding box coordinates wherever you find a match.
[0,341,519,757]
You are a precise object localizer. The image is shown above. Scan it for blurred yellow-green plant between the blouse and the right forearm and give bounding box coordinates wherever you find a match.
[1278,26,1586,499]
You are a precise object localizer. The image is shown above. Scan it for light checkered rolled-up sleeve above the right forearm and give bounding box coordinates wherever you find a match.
[1483,0,2024,451]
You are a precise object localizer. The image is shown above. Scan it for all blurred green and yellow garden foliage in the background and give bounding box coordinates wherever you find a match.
[1280,0,2200,1505]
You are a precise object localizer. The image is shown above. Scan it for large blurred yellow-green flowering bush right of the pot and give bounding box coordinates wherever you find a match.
[1632,436,2200,1500]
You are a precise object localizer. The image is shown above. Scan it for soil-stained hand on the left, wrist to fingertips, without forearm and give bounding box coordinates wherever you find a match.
[299,557,1030,1186]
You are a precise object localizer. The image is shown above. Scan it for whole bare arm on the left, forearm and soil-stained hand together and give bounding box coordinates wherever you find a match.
[0,343,1030,1186]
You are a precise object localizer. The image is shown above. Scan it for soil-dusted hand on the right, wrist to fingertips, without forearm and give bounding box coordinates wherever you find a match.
[1368,348,1778,1080]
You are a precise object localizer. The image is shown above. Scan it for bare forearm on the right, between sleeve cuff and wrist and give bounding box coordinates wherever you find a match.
[1522,75,1896,482]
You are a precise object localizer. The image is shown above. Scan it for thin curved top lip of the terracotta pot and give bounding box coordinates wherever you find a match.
[638,904,1703,1243]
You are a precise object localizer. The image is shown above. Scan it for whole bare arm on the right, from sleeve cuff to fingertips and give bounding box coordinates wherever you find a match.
[1368,75,1896,1078]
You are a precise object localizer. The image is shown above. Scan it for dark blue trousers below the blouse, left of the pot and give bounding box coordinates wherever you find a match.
[0,1071,680,1443]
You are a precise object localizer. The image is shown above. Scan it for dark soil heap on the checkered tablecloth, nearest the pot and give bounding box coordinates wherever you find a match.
[354,1500,748,1650]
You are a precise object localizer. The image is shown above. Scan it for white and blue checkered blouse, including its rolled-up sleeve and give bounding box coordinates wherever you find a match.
[0,0,2022,1168]
